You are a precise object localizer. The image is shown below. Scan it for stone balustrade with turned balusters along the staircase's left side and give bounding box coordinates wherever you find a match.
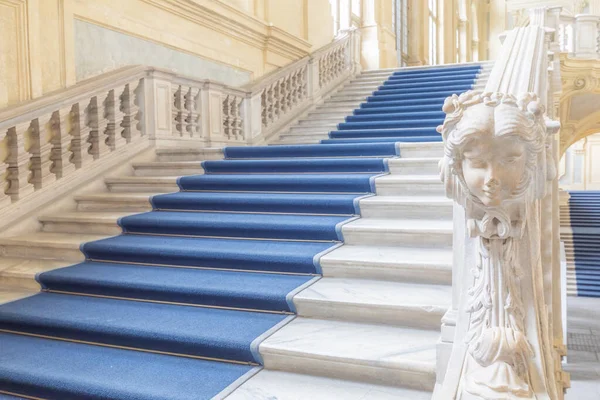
[0,30,360,212]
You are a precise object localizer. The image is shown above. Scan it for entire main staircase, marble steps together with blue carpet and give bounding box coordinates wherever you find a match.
[0,65,489,400]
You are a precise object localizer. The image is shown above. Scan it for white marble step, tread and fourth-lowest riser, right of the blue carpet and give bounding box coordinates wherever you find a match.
[342,218,453,248]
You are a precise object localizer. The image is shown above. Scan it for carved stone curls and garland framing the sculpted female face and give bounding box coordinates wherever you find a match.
[437,91,546,206]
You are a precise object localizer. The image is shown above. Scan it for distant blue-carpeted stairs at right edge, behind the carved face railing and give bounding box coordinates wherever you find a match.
[560,190,600,297]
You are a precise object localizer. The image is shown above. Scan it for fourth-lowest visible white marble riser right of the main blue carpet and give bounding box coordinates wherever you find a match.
[342,225,452,248]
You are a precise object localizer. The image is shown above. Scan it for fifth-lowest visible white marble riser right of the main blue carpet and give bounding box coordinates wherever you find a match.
[360,203,452,220]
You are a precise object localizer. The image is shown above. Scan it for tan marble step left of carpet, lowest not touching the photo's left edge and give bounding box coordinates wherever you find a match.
[38,211,131,235]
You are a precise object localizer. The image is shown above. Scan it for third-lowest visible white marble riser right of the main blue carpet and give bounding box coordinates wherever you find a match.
[321,259,452,285]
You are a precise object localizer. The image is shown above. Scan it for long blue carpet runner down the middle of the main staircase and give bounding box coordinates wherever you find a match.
[0,66,480,400]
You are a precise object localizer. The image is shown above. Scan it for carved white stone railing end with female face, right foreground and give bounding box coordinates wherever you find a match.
[434,9,569,400]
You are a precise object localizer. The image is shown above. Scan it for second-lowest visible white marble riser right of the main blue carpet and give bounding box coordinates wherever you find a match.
[294,300,447,329]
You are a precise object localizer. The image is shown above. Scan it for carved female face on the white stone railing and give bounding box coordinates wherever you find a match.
[457,104,526,207]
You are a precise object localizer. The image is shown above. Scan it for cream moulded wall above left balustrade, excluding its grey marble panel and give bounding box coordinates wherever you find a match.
[0,0,333,107]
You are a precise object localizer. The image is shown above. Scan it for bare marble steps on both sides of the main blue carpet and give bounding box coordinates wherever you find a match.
[0,62,489,400]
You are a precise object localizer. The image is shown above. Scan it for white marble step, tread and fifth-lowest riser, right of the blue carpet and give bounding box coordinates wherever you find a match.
[360,196,453,220]
